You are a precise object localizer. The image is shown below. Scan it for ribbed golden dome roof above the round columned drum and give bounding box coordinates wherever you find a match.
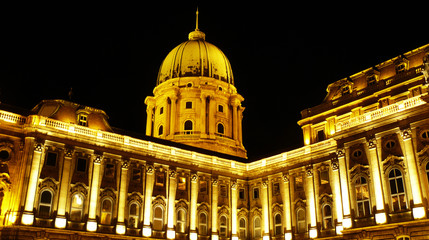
[156,27,234,85]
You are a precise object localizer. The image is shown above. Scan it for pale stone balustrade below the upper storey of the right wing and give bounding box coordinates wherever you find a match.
[335,96,426,132]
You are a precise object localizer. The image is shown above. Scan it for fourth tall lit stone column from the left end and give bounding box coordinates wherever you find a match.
[116,161,129,234]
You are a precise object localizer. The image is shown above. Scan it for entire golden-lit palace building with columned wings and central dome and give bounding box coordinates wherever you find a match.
[0,13,429,240]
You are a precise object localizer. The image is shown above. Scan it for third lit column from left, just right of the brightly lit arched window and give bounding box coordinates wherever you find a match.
[86,155,102,232]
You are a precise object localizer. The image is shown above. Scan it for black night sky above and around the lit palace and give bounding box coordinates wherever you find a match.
[0,1,429,158]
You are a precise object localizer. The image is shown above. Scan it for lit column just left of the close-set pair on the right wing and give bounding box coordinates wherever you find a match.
[305,165,317,238]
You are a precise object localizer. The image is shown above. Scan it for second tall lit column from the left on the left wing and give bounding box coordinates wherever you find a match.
[55,148,73,228]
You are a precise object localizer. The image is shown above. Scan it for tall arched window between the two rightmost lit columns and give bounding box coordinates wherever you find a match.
[389,168,407,211]
